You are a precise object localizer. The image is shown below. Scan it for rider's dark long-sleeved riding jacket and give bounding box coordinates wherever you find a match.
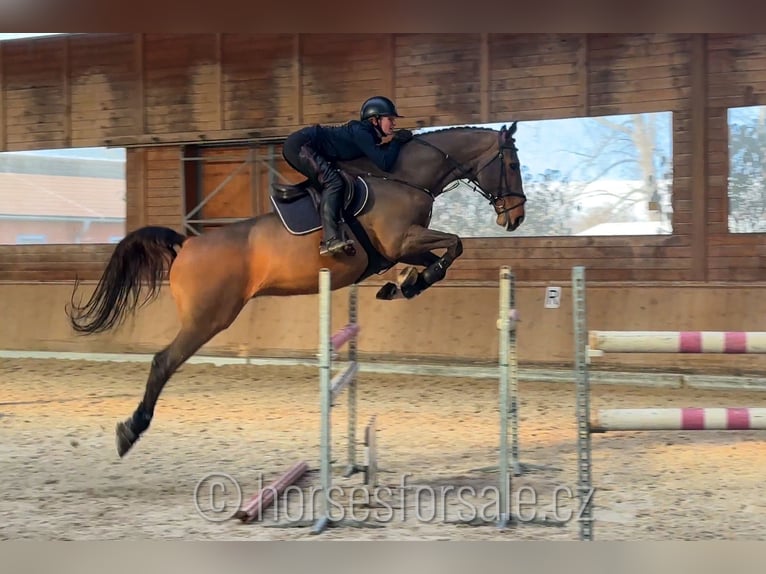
[309,120,402,171]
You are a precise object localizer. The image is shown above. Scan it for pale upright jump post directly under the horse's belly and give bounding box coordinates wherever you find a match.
[314,268,332,533]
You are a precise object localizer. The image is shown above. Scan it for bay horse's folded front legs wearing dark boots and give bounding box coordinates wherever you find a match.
[376,226,463,299]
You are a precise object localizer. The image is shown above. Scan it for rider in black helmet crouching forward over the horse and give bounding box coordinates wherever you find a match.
[282,96,412,255]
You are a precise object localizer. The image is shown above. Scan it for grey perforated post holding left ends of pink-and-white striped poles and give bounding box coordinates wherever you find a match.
[572,266,593,540]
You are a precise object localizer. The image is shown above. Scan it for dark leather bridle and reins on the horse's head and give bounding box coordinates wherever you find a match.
[360,131,527,215]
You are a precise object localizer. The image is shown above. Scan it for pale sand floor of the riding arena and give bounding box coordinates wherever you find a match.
[0,359,766,540]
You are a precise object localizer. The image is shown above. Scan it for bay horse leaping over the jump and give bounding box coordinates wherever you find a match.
[66,122,526,457]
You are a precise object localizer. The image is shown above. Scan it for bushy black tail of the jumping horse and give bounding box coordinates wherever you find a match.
[67,226,187,334]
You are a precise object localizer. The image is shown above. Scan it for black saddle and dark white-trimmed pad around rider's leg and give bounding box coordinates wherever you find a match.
[271,171,369,235]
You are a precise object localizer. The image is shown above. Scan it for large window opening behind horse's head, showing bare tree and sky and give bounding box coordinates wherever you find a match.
[423,112,673,237]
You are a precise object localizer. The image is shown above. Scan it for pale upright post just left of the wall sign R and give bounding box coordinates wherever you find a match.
[497,266,511,528]
